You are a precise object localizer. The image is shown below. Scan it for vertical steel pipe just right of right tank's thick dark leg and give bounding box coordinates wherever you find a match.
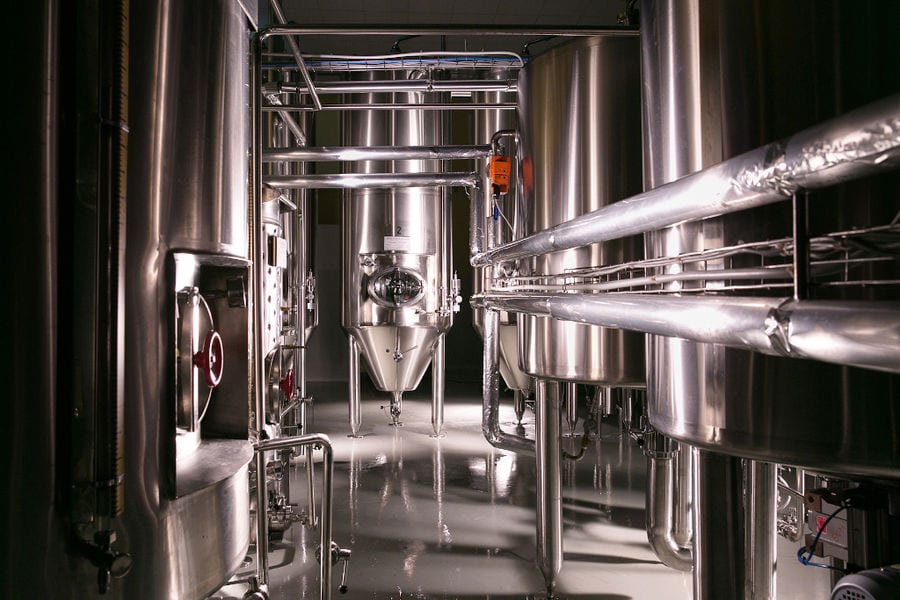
[744,460,778,600]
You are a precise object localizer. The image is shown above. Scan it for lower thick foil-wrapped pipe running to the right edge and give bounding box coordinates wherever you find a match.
[484,293,900,373]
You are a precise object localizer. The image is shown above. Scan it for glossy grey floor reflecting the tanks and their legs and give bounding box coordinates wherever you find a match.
[212,384,821,600]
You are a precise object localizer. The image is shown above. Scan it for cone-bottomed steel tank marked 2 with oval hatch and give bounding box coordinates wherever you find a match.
[341,71,453,433]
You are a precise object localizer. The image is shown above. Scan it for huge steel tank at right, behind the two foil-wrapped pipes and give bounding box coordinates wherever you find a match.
[643,2,900,477]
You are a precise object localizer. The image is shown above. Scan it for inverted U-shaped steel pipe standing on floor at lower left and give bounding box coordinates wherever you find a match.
[254,433,334,600]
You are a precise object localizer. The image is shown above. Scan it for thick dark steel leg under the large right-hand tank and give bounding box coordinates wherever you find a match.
[693,448,746,600]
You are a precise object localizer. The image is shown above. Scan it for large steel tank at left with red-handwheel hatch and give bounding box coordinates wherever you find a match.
[11,0,252,600]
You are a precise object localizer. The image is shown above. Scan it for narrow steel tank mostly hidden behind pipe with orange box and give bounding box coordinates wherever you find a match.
[472,69,534,393]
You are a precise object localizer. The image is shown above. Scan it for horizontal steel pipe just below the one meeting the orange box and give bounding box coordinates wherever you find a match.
[265,172,480,190]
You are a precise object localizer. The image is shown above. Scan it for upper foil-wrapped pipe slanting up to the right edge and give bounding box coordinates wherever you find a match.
[471,94,900,267]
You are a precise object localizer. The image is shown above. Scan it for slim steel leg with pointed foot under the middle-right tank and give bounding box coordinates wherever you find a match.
[534,379,563,596]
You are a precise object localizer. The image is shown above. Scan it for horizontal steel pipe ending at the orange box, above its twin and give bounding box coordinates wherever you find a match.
[262,145,491,162]
